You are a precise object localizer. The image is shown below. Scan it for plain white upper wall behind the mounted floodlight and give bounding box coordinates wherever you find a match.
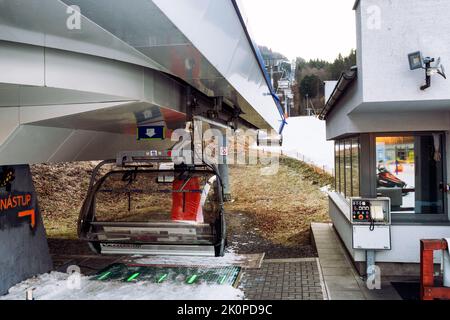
[356,0,450,102]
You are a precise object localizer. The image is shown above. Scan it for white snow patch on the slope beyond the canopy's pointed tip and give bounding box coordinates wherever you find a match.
[282,117,334,173]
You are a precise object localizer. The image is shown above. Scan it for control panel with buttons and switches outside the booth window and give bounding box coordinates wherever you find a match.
[350,198,391,226]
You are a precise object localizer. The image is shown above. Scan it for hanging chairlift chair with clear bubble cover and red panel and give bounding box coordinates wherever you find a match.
[78,152,226,256]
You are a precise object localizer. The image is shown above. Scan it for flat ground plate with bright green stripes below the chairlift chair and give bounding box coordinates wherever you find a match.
[94,263,241,286]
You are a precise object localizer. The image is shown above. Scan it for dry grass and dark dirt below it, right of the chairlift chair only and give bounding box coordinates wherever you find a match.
[225,157,333,258]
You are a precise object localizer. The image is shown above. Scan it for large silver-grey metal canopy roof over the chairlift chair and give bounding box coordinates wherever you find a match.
[0,0,284,165]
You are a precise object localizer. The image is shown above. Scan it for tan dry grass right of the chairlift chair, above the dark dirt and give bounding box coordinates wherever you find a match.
[226,157,333,246]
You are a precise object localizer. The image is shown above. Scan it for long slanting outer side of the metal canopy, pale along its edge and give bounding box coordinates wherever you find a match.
[58,0,283,129]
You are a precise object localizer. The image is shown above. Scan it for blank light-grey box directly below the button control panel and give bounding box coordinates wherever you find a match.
[353,225,391,250]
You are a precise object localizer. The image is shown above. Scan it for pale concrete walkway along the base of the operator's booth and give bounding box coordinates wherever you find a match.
[311,223,401,300]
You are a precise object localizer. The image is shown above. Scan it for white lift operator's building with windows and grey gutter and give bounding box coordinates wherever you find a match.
[321,0,450,284]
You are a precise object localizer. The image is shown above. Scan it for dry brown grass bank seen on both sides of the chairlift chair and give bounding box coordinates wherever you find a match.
[32,158,332,242]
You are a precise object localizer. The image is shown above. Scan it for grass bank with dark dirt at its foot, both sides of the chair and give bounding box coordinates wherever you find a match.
[32,158,332,258]
